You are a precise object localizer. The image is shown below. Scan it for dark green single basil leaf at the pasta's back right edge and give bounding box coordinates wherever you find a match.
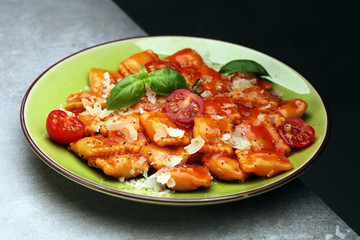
[219,59,270,77]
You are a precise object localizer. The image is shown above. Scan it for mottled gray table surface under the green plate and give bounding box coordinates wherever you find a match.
[0,0,360,239]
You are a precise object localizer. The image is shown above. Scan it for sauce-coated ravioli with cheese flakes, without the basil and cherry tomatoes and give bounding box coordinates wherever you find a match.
[45,48,316,192]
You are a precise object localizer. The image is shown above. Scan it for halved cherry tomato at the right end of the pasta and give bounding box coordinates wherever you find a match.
[277,118,315,148]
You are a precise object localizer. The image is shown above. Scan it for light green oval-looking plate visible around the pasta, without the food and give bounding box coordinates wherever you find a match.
[20,36,330,205]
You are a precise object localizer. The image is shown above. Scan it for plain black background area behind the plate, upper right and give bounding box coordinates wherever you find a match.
[115,0,360,234]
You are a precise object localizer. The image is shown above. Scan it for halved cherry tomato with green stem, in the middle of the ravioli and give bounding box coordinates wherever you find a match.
[165,89,204,125]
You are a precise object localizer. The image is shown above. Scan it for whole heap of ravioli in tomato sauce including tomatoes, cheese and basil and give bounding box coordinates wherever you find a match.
[46,48,315,192]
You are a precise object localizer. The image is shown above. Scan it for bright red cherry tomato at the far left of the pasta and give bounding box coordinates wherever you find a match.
[46,110,85,144]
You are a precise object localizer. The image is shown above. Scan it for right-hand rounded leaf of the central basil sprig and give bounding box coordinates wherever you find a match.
[148,68,188,96]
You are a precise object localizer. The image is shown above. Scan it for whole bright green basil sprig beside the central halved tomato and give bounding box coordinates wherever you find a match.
[105,65,187,110]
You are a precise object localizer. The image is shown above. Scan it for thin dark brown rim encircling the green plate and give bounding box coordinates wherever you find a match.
[20,35,331,205]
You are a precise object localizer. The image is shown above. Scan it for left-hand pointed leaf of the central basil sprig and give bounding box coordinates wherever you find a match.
[105,75,145,110]
